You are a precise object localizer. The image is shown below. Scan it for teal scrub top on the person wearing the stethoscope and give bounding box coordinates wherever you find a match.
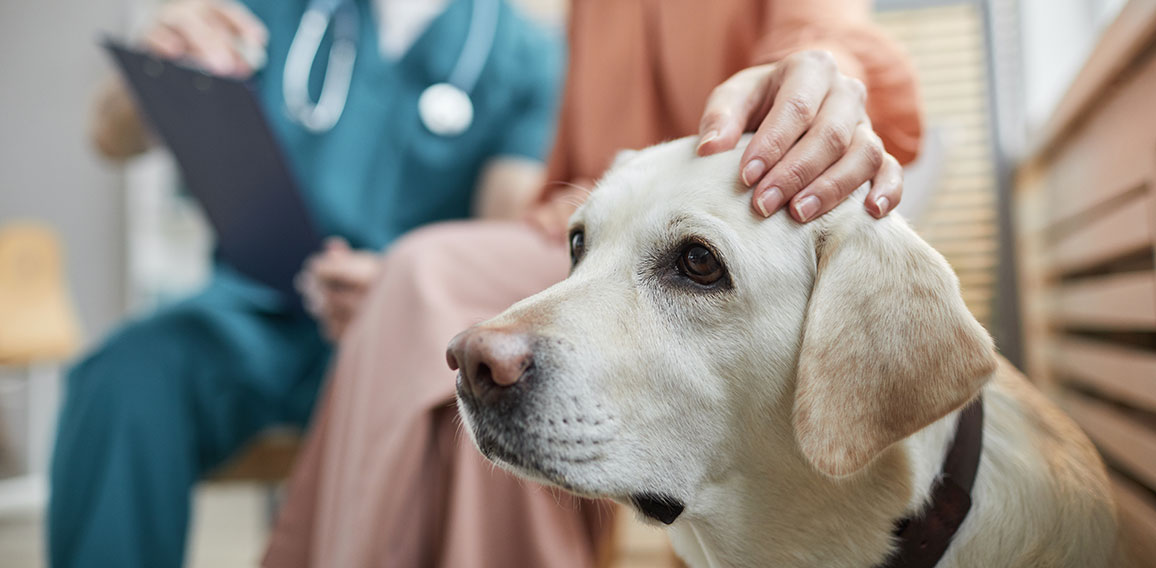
[210,0,564,307]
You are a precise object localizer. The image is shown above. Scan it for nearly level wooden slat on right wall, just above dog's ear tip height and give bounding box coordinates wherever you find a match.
[1050,271,1156,331]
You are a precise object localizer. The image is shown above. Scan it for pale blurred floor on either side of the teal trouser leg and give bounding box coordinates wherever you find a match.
[0,484,268,568]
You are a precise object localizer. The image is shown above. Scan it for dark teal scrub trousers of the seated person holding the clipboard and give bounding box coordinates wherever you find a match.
[49,287,329,568]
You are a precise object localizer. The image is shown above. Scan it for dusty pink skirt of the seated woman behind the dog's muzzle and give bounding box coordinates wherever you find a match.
[262,221,613,568]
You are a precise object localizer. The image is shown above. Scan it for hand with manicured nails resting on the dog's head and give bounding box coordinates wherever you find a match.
[698,51,903,222]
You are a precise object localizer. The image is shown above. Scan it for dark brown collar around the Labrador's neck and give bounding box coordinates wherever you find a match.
[879,397,984,568]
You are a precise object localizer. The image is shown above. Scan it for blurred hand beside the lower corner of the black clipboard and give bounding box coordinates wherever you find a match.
[296,237,381,341]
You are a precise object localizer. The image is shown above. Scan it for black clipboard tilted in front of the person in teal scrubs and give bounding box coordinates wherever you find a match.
[103,39,321,308]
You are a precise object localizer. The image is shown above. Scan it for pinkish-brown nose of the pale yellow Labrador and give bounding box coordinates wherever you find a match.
[445,327,533,398]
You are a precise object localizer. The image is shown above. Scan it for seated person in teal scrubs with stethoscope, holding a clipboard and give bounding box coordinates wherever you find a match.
[49,0,562,568]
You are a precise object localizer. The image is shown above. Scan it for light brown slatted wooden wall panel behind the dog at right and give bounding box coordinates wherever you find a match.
[1015,0,1156,567]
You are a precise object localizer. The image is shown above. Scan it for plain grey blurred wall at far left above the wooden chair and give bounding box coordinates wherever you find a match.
[0,0,127,340]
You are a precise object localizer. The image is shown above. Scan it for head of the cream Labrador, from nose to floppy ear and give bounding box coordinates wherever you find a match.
[447,139,995,523]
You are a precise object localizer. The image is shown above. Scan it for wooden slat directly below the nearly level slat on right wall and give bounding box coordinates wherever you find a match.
[1048,337,1156,412]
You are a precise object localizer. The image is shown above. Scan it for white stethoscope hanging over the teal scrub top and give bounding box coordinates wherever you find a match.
[281,0,498,137]
